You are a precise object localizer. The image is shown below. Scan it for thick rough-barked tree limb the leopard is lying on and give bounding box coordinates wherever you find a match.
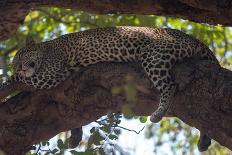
[0,61,232,154]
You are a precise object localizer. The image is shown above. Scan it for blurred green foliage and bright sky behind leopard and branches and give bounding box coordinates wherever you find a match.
[0,8,232,155]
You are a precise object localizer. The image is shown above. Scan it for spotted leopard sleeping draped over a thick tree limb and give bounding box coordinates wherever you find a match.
[1,26,219,151]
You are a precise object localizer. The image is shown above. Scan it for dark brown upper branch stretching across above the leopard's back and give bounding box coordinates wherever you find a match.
[0,0,232,40]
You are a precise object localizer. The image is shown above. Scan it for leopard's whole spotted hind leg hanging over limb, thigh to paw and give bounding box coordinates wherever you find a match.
[138,46,176,123]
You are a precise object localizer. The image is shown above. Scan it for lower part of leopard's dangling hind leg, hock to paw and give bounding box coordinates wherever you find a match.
[150,83,176,123]
